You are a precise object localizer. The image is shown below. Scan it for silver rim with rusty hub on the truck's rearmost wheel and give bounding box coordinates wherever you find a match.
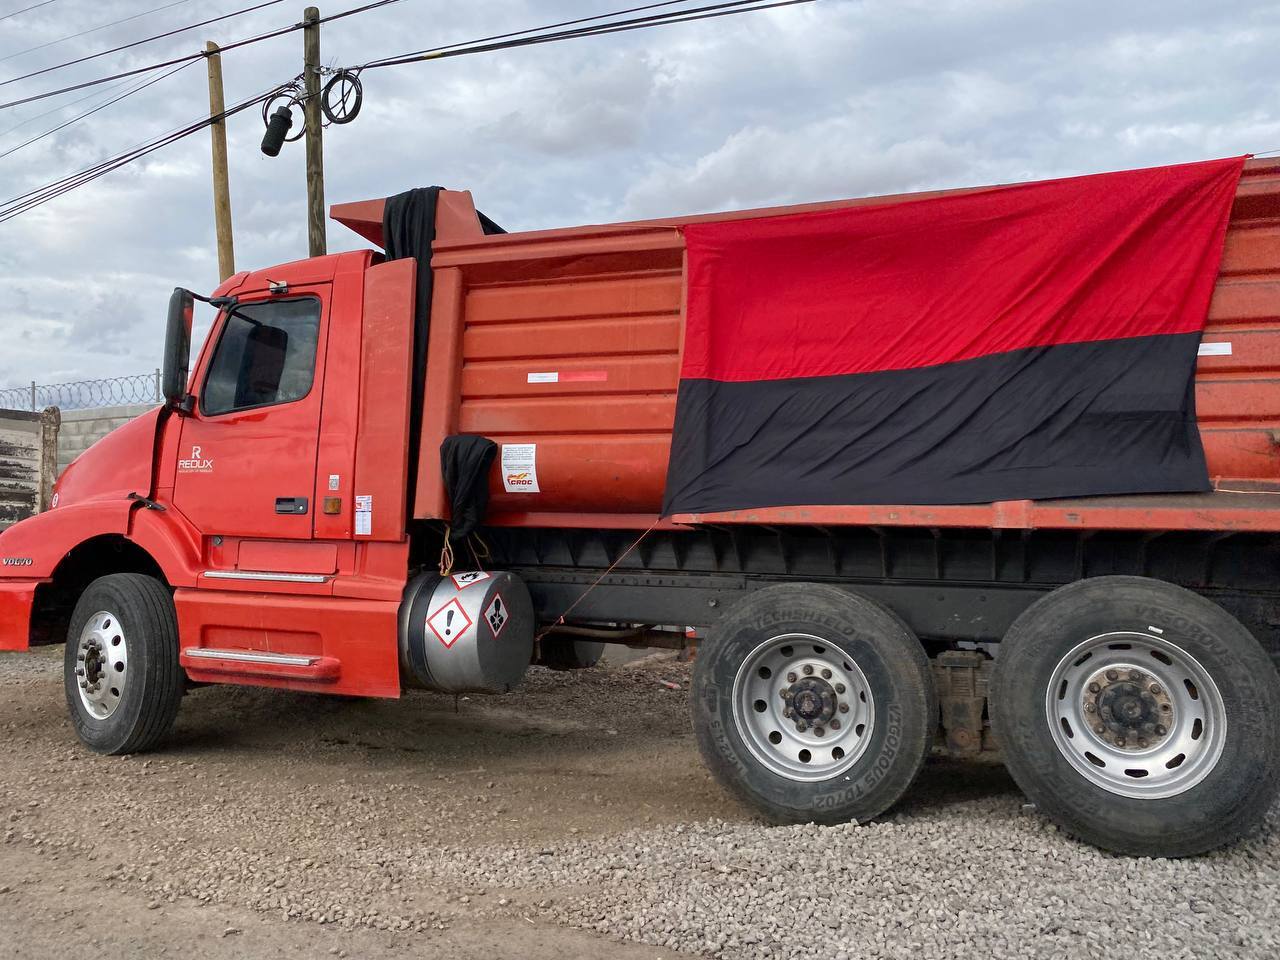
[1044,632,1226,800]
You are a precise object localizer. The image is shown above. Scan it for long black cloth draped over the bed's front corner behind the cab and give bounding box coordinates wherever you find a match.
[383,187,443,517]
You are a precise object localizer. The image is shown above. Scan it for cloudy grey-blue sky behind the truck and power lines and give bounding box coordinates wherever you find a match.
[0,0,1280,387]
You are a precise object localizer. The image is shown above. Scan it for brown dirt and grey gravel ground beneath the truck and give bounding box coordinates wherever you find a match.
[0,648,1280,960]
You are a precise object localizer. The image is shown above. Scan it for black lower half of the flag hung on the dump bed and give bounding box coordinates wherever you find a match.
[663,333,1210,515]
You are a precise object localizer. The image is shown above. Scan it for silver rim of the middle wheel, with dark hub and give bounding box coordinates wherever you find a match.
[733,634,876,781]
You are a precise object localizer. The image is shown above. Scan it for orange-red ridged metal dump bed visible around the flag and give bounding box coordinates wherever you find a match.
[333,159,1280,530]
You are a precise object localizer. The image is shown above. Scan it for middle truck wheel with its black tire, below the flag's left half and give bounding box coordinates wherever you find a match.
[691,584,937,823]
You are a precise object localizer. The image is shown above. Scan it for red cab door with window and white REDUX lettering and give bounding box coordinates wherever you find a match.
[173,288,326,539]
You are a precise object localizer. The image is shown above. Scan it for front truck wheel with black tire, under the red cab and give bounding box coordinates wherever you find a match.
[63,573,184,754]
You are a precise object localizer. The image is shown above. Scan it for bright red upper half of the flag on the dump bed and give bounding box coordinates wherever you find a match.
[681,157,1244,381]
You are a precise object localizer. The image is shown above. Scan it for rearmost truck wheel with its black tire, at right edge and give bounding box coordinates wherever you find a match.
[991,576,1280,856]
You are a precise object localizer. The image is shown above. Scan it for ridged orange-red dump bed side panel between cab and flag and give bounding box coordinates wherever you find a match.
[458,261,682,511]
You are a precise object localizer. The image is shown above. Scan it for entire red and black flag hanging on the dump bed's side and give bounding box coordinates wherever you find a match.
[663,157,1243,515]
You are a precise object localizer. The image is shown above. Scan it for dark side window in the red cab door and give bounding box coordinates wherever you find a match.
[200,297,320,416]
